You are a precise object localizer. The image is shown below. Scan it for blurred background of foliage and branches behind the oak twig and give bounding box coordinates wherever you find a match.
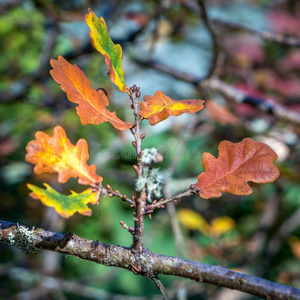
[0,0,300,300]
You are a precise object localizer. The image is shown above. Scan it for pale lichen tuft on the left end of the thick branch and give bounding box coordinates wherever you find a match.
[8,224,39,254]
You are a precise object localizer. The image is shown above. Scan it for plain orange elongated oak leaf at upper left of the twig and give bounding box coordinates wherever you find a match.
[50,56,133,130]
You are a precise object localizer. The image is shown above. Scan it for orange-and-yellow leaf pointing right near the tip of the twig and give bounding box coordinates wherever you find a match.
[139,91,204,125]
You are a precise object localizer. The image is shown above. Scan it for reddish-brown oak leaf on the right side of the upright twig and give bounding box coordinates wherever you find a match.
[194,138,279,199]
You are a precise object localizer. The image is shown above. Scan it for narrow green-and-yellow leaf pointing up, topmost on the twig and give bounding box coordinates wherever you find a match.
[85,9,129,93]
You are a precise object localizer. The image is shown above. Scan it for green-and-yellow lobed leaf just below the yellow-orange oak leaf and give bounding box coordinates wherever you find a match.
[27,183,99,218]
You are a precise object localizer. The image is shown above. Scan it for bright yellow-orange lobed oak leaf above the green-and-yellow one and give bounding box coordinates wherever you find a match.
[25,126,103,185]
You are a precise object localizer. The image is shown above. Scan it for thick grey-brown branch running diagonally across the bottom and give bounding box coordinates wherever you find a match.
[0,221,300,300]
